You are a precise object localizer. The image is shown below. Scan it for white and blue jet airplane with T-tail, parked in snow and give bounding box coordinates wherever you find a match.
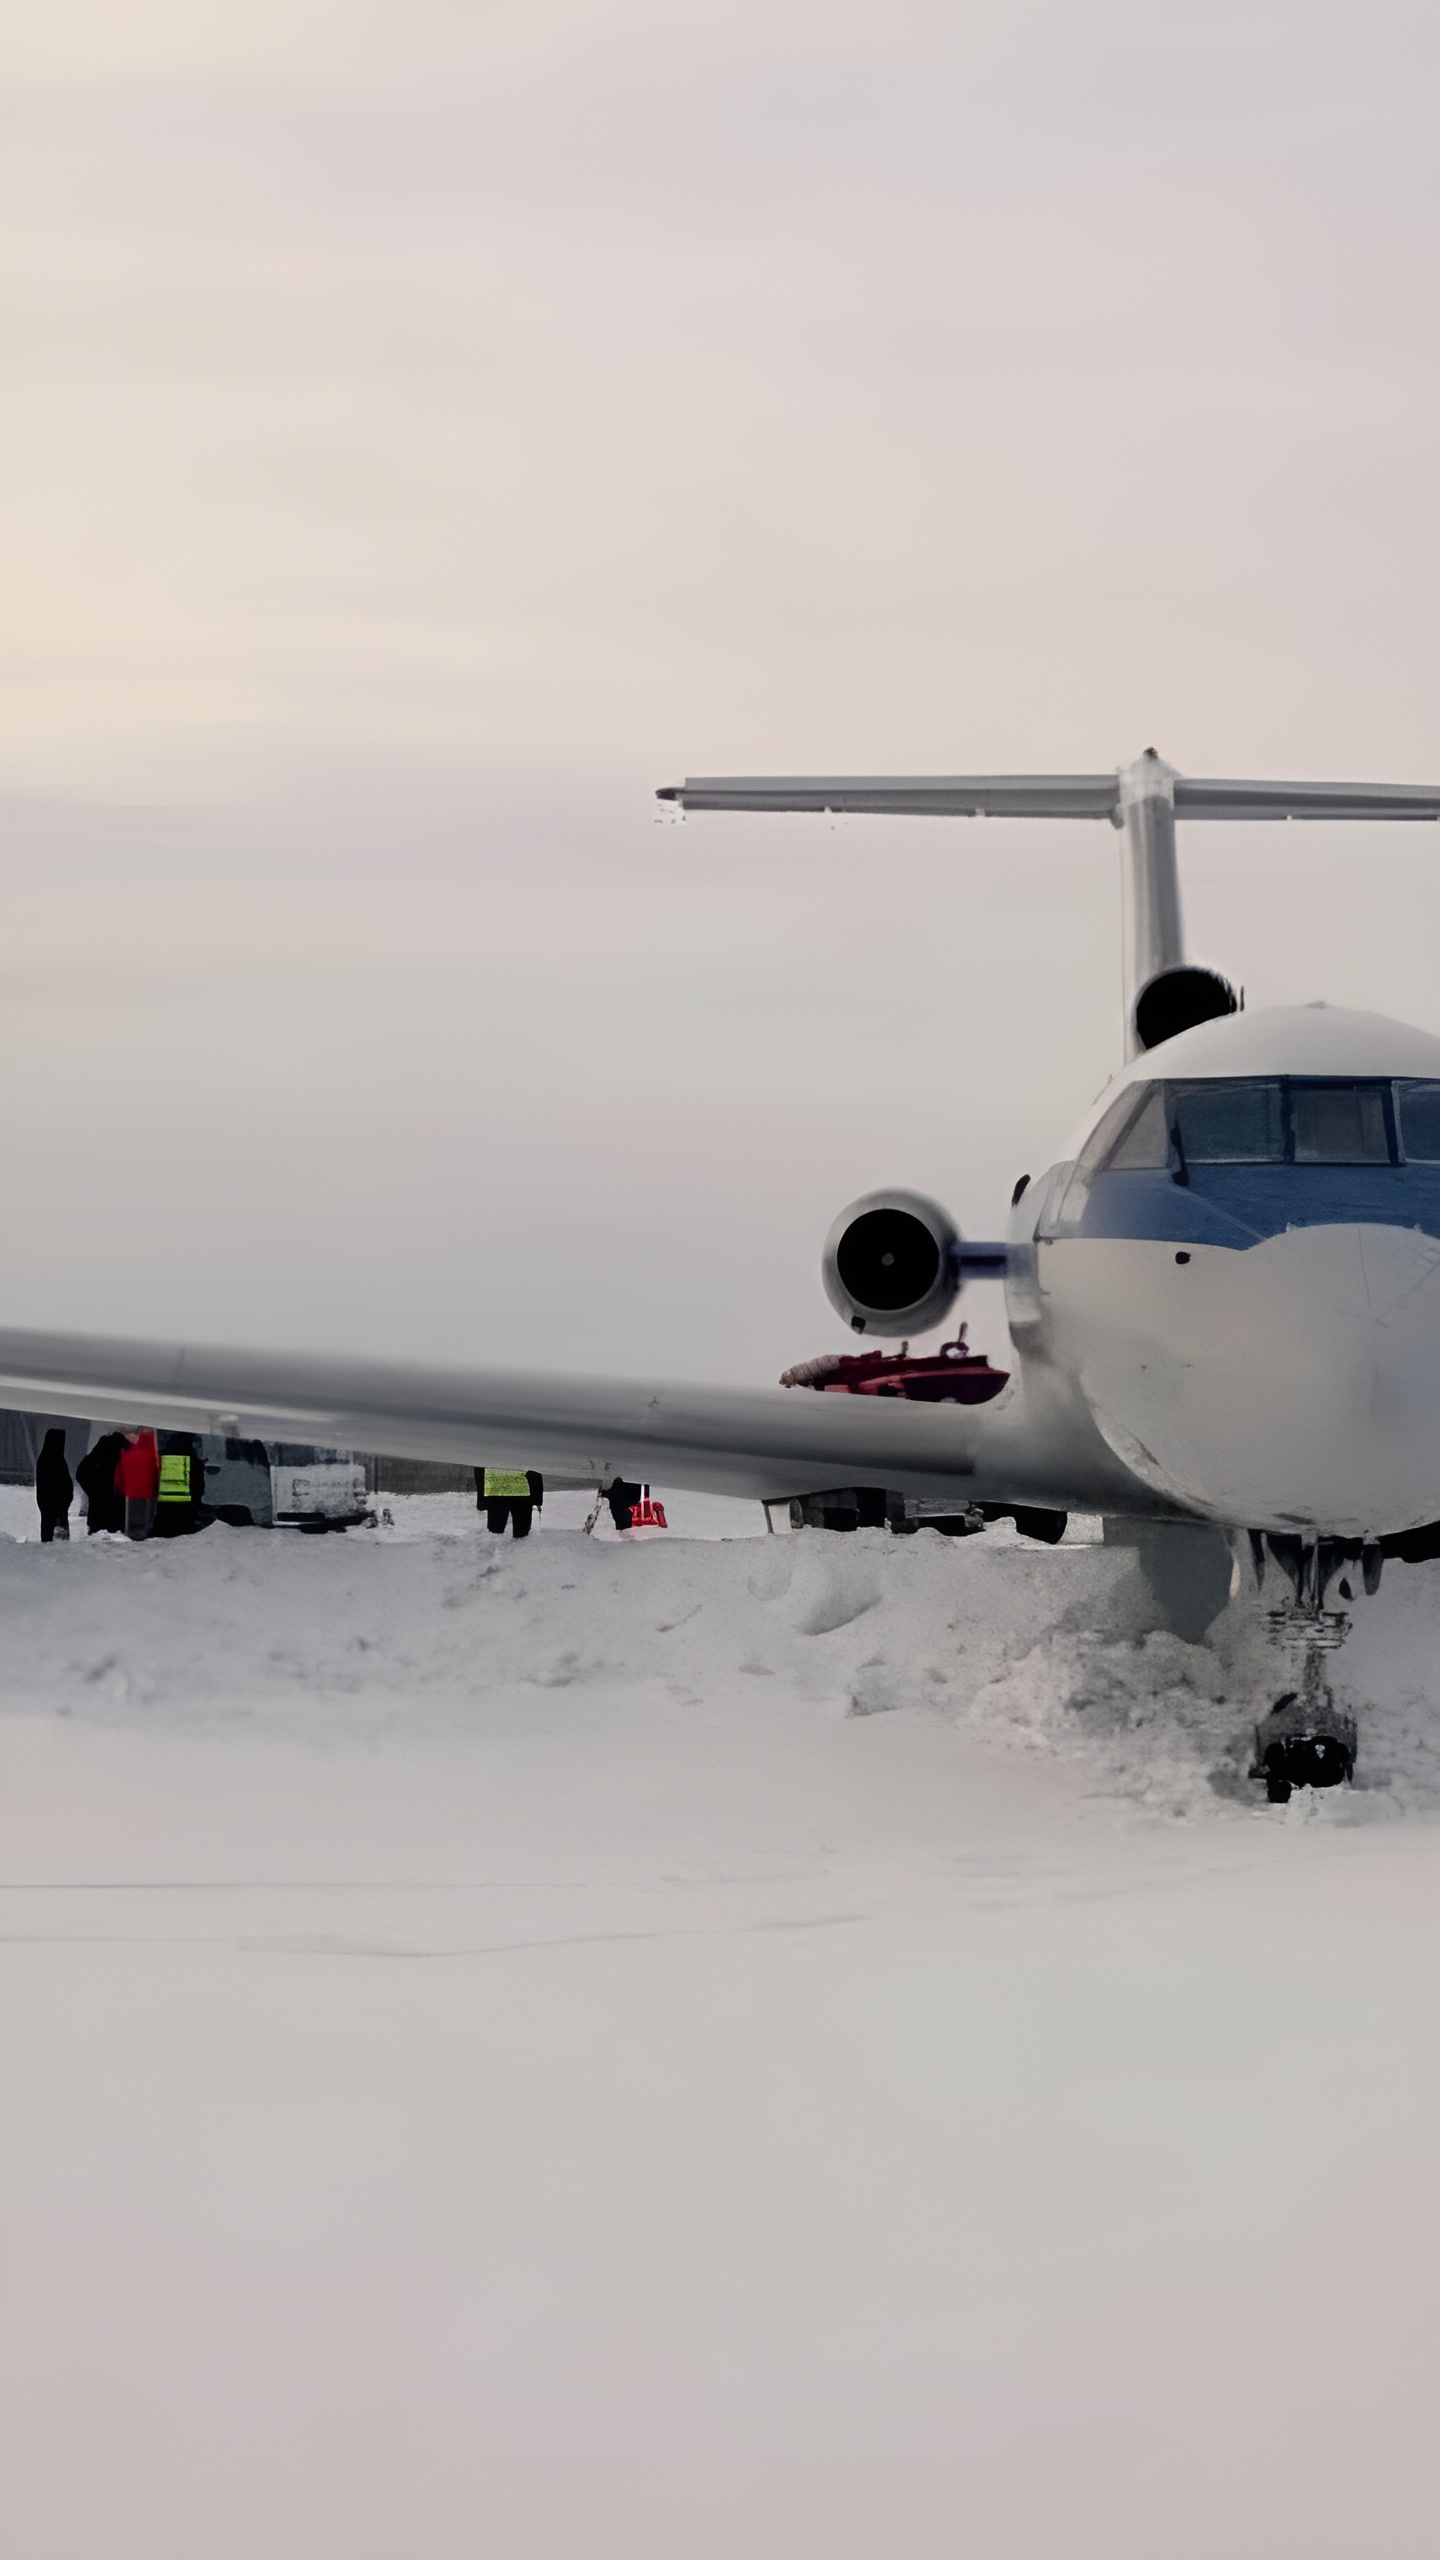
[0,748,1440,1802]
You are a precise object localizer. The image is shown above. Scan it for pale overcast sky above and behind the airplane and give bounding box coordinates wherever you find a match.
[0,0,1440,1377]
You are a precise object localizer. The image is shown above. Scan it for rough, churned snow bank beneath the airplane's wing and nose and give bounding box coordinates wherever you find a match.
[0,1492,1440,1823]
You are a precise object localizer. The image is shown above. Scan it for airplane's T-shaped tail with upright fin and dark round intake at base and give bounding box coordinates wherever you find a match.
[656,748,1440,1057]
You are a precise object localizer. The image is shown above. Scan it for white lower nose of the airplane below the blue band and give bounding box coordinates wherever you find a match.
[1045,1224,1440,1536]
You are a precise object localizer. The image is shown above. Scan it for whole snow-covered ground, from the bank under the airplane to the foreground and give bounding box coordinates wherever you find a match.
[0,1495,1440,2560]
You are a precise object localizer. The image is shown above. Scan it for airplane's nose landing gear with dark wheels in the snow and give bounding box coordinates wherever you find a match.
[1250,1533,1379,1805]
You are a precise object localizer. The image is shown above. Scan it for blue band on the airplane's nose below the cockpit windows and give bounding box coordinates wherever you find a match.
[1051,1165,1440,1252]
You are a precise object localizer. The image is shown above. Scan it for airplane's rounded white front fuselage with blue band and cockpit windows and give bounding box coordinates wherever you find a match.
[1010,1006,1440,1539]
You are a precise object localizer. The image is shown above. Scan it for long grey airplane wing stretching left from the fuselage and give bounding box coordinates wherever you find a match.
[0,1329,1156,1513]
